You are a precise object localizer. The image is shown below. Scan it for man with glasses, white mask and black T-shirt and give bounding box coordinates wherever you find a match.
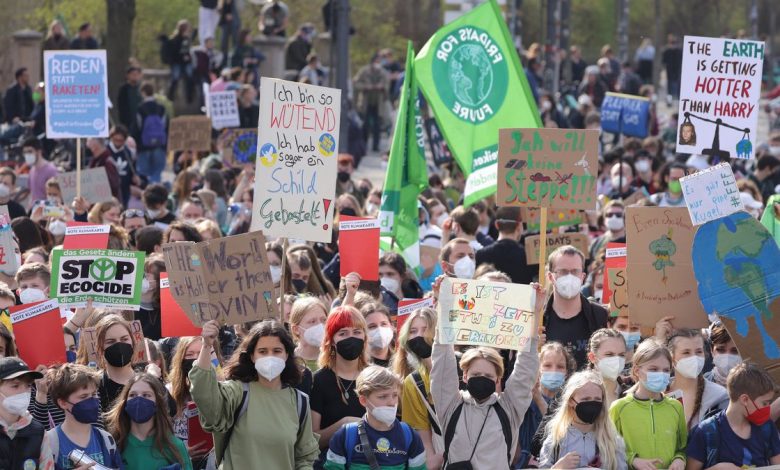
[544,245,608,370]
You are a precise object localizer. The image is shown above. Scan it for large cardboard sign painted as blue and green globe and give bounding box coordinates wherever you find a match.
[693,212,780,380]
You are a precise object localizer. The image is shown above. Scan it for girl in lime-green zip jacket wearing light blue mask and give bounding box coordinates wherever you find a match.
[609,338,688,470]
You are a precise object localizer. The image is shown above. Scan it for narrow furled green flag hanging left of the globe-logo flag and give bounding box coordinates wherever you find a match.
[379,42,428,268]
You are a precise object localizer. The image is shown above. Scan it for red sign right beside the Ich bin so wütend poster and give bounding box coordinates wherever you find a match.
[339,215,379,281]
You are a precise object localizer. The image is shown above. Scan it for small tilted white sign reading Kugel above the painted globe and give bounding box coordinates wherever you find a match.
[680,163,745,225]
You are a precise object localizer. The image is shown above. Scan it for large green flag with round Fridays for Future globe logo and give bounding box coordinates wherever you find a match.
[414,0,542,206]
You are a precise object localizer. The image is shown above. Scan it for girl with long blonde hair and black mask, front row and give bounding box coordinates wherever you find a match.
[539,370,626,470]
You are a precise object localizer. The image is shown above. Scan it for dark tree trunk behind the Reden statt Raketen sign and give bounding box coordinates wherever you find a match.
[106,0,135,120]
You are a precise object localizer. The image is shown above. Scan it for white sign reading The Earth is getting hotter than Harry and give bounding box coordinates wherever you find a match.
[677,36,765,162]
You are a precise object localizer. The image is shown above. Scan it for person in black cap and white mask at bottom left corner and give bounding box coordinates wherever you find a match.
[0,356,45,470]
